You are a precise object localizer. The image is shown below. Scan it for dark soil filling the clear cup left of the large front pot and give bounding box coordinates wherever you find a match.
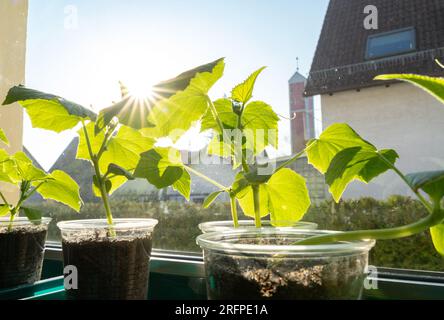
[63,236,152,300]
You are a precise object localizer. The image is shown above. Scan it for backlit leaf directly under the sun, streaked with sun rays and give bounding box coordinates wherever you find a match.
[95,83,154,134]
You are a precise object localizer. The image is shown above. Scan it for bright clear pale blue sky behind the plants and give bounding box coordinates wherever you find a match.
[24,0,328,169]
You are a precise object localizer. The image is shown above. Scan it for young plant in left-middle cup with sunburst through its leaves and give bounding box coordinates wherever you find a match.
[3,60,227,235]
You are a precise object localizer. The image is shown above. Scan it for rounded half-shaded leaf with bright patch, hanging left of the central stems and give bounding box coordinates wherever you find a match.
[134,147,184,189]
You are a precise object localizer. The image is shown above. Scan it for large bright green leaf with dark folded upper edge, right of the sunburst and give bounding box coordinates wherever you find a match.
[143,59,225,141]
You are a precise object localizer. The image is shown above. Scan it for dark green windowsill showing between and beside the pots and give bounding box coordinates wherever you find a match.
[0,257,444,300]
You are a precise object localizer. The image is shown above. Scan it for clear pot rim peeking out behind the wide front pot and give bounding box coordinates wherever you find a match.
[199,220,318,233]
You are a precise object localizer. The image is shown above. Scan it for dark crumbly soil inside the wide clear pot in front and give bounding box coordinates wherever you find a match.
[205,236,368,300]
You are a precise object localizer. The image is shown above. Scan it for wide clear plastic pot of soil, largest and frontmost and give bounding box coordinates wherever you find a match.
[197,228,375,300]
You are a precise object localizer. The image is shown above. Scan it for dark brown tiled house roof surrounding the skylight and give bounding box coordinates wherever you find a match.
[305,0,444,96]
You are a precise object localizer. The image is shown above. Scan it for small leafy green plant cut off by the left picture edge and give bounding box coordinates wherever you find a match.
[0,129,82,231]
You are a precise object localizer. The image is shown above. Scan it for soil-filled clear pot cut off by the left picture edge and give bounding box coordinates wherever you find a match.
[0,217,51,289]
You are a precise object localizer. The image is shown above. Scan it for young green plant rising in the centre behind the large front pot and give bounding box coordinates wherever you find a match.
[135,60,310,227]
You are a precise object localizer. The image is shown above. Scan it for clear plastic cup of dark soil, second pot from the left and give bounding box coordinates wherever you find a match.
[57,219,157,300]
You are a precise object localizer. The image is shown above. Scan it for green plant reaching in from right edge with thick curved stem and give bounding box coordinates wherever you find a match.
[299,64,444,255]
